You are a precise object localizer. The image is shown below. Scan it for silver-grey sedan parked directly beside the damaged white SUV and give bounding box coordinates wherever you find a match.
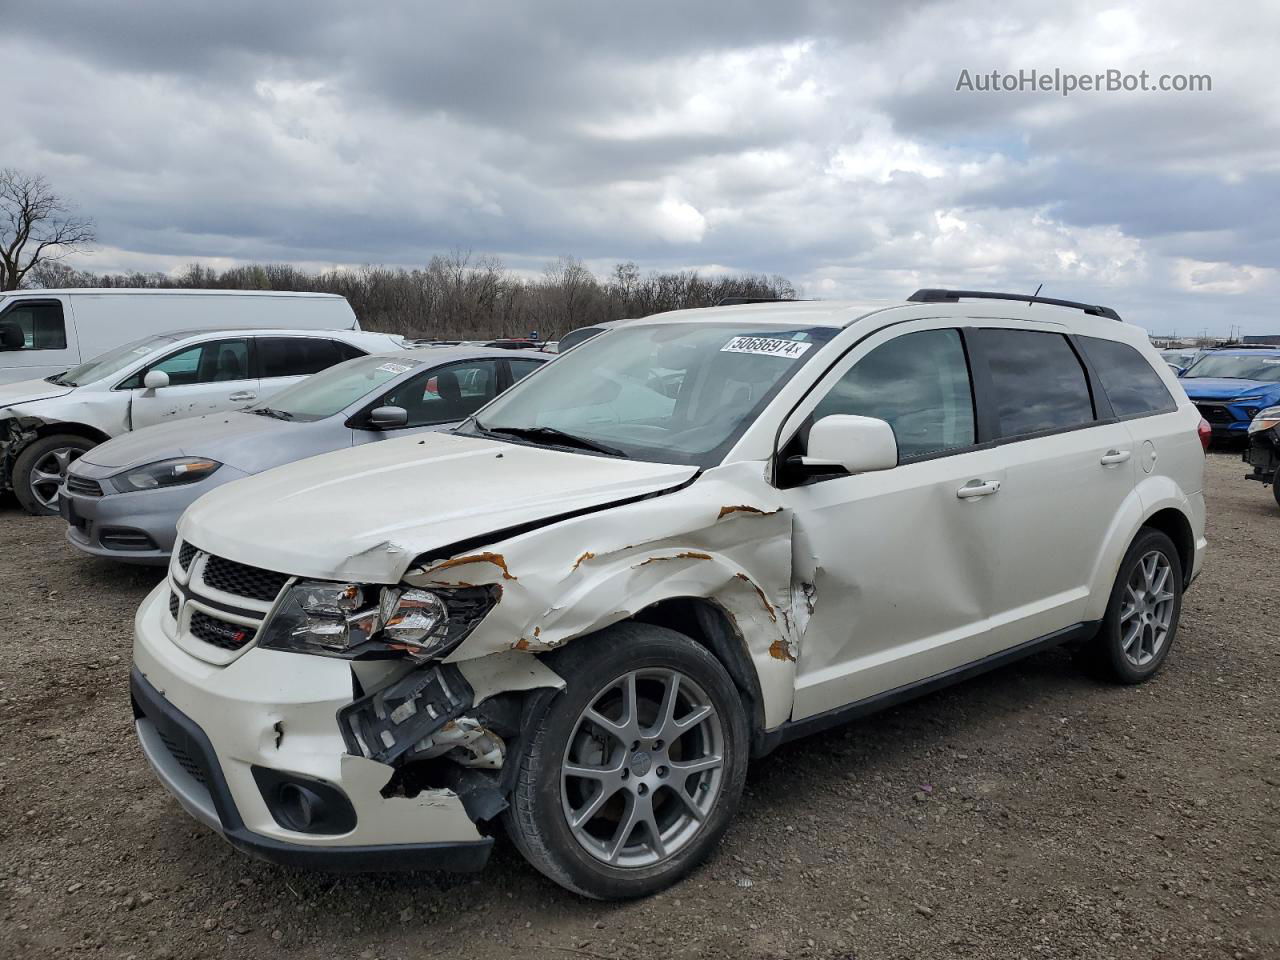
[59,347,549,564]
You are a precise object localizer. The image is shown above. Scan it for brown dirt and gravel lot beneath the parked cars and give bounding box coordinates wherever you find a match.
[0,453,1280,960]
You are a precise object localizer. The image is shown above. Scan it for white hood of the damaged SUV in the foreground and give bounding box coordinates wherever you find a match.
[178,434,696,584]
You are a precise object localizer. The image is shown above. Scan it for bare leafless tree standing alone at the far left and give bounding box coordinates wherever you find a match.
[0,166,93,291]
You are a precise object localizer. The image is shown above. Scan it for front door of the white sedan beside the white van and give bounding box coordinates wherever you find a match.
[125,337,257,430]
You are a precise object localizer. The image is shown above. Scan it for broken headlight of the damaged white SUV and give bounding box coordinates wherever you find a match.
[259,580,500,662]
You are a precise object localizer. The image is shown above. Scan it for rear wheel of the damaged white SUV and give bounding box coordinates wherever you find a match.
[1084,527,1183,684]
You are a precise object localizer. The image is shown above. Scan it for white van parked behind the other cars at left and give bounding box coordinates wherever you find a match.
[0,288,360,384]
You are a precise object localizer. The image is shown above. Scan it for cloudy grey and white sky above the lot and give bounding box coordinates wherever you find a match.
[10,0,1280,333]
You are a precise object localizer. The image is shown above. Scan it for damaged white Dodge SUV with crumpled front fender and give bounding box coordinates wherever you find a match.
[132,291,1204,897]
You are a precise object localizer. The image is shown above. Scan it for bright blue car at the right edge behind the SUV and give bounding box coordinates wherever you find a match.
[1181,347,1280,440]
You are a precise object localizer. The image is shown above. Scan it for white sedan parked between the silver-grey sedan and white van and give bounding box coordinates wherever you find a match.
[0,329,401,513]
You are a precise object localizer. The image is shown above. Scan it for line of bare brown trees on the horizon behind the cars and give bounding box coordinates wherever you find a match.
[26,251,796,339]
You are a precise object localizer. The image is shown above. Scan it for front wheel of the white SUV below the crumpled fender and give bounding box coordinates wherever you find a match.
[503,622,748,900]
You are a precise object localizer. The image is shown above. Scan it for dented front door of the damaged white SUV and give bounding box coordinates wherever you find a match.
[782,320,1004,719]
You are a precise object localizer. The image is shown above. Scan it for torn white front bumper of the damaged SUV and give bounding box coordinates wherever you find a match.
[131,585,493,870]
